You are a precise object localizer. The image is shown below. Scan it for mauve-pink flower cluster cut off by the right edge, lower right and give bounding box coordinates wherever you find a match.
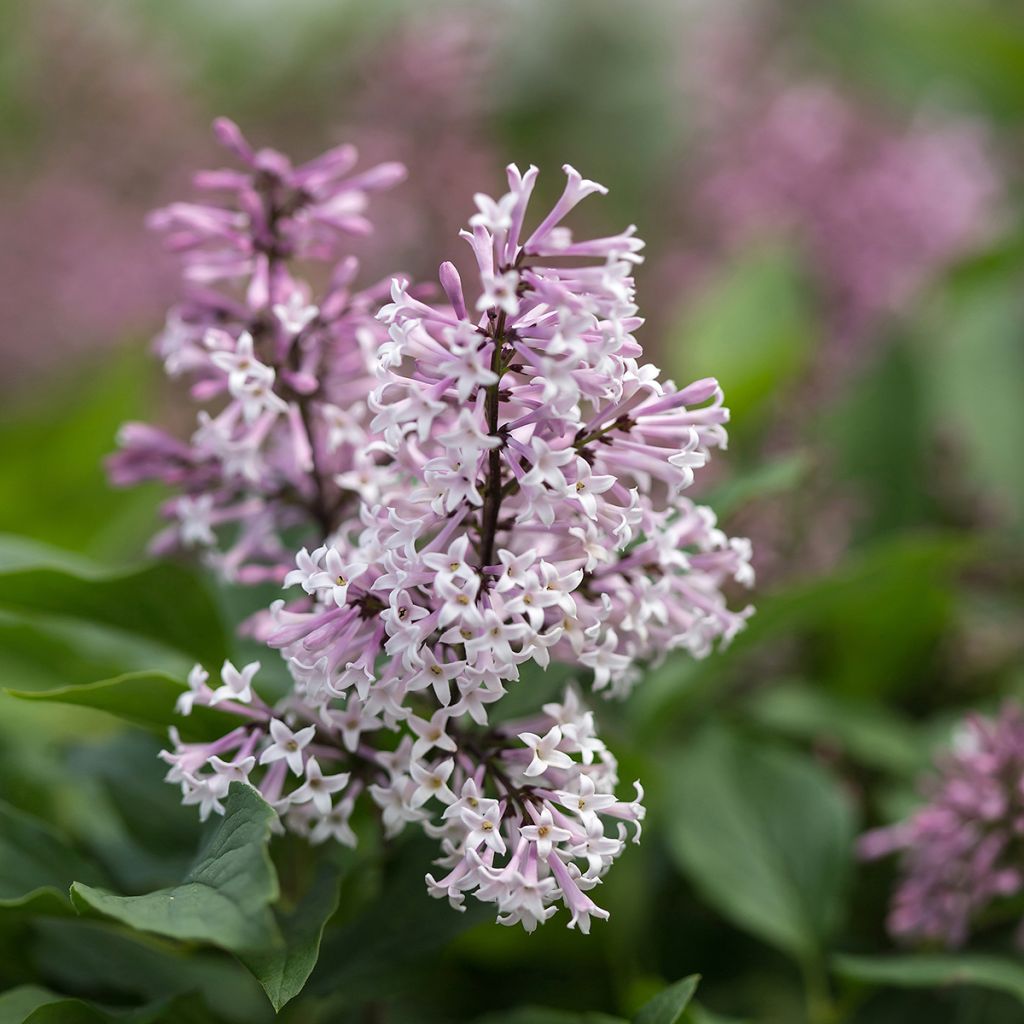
[860,705,1024,946]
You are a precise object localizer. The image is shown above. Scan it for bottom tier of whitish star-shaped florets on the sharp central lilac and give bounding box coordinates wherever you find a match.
[161,663,644,933]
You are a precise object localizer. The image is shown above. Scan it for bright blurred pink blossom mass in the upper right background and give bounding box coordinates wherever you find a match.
[693,75,1001,343]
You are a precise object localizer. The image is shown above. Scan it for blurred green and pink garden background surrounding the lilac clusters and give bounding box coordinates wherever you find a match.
[0,0,1024,1024]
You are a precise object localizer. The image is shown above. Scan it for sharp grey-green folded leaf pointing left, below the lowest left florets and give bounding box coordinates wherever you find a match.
[72,782,281,953]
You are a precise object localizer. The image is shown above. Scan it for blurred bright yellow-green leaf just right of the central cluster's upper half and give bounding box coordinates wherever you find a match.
[666,246,815,430]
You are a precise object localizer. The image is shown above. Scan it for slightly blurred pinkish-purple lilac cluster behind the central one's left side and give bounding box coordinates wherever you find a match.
[110,119,404,583]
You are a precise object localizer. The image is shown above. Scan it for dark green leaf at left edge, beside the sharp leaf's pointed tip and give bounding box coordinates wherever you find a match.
[0,803,102,913]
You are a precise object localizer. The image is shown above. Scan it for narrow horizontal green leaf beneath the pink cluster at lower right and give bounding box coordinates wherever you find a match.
[831,953,1024,1002]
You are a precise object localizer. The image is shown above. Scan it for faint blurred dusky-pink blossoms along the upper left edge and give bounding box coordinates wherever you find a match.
[0,0,209,388]
